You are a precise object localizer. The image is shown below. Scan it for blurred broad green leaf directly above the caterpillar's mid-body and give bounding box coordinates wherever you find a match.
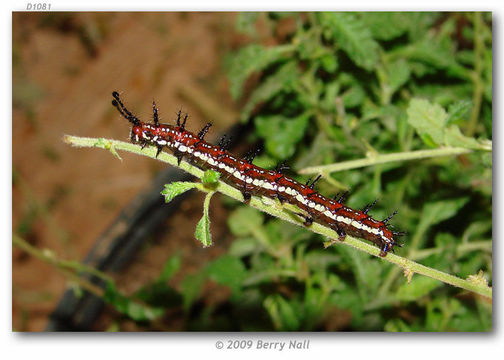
[254,113,310,160]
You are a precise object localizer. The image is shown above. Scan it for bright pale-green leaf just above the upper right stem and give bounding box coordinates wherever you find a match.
[407,99,448,147]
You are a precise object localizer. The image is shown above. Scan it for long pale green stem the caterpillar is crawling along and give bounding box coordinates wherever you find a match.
[64,135,492,298]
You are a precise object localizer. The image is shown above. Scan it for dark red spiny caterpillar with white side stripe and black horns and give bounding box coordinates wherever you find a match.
[112,91,403,257]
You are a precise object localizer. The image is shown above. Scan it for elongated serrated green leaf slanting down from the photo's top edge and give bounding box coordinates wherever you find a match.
[317,12,379,70]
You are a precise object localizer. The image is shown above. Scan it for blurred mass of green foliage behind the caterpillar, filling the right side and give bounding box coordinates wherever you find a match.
[119,13,492,331]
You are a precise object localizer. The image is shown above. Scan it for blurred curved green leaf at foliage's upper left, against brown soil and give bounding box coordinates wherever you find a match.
[229,44,292,99]
